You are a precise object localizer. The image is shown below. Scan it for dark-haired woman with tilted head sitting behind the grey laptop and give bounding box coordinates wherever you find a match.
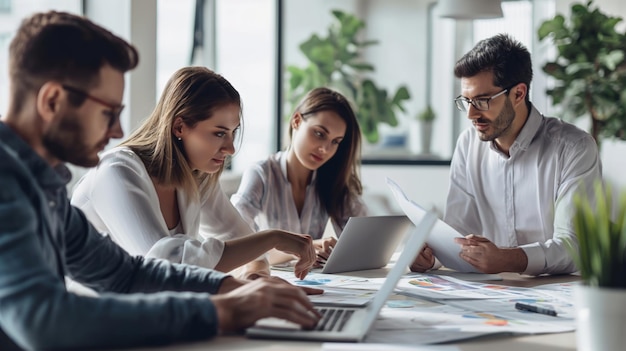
[231,88,367,264]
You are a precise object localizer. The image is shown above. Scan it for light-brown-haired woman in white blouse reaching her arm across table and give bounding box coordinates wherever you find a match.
[72,67,315,278]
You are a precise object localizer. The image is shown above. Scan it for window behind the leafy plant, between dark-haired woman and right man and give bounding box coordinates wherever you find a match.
[280,0,451,164]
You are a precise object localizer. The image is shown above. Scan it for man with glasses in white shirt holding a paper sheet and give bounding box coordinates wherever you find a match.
[411,34,601,275]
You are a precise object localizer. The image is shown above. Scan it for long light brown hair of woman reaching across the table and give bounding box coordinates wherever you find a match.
[120,67,243,195]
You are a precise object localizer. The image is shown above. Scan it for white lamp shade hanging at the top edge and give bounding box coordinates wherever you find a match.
[437,0,503,19]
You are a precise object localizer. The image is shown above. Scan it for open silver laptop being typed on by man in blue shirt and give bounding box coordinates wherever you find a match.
[246,212,437,342]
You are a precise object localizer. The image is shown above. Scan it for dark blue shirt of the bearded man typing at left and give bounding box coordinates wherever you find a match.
[0,173,223,349]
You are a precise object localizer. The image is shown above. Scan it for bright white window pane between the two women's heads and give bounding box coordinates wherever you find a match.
[215,0,277,171]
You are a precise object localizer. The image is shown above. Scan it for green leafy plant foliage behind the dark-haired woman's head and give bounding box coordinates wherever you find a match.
[286,10,410,143]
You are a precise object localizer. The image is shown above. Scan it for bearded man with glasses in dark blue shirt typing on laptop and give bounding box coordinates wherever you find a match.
[0,11,320,351]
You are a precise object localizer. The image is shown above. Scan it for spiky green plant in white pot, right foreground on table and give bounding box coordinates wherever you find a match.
[568,183,626,351]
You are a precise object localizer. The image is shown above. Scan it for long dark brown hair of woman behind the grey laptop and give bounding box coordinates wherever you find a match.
[289,88,363,223]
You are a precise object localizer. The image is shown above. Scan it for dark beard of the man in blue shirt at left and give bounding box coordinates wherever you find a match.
[43,113,100,167]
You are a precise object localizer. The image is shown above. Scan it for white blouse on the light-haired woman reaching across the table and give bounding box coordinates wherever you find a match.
[71,147,252,268]
